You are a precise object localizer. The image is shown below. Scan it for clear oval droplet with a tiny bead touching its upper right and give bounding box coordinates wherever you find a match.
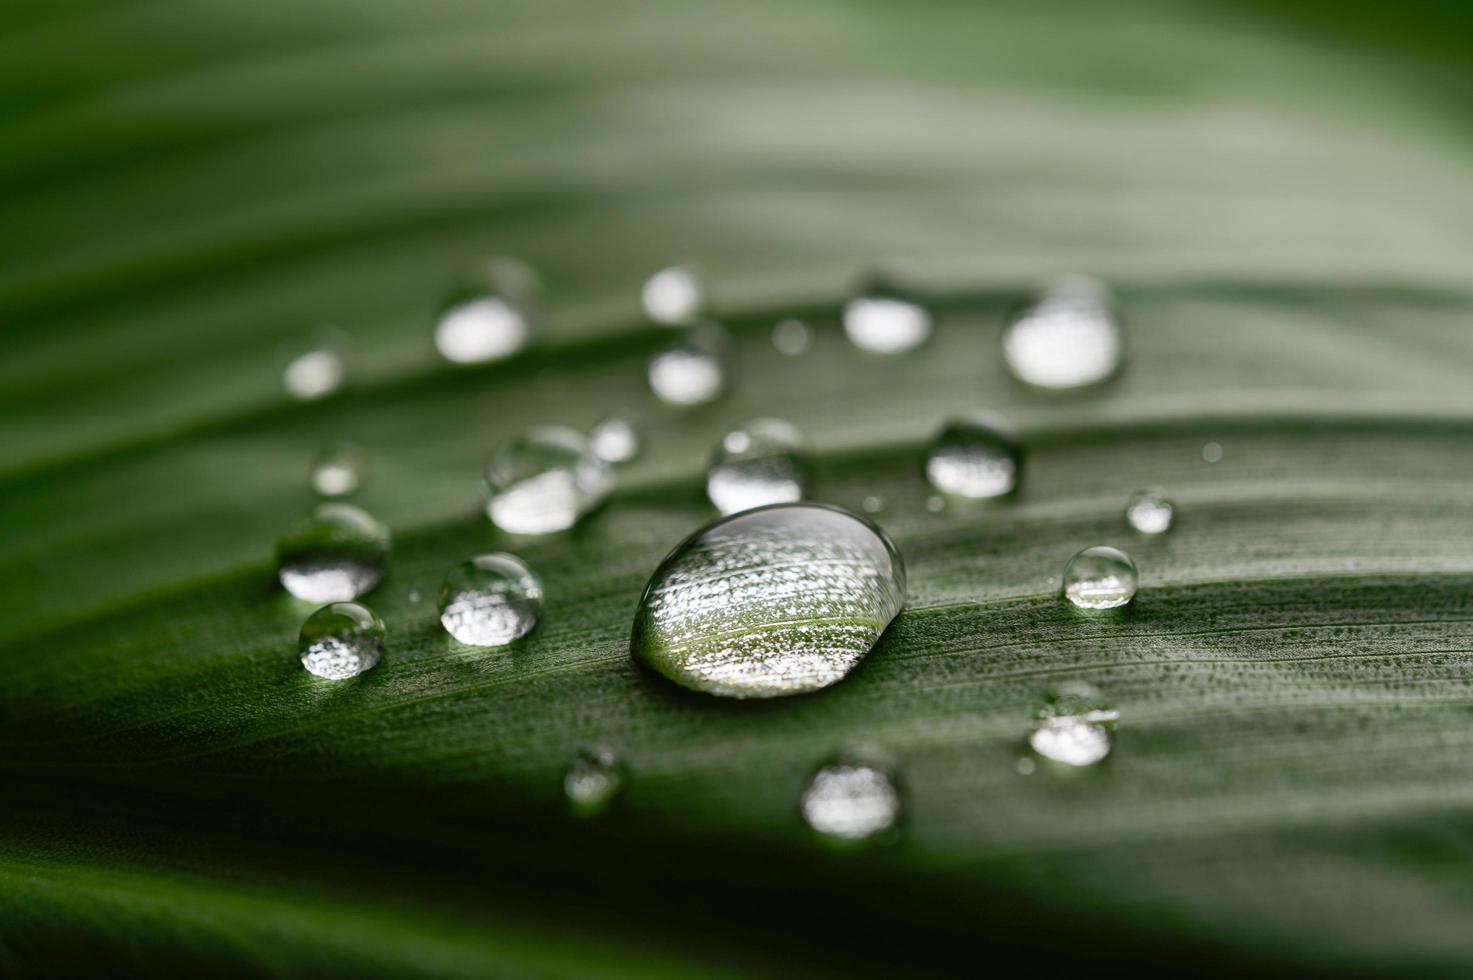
[486,426,614,535]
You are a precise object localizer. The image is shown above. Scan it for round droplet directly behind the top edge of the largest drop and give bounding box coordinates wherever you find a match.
[706,419,809,514]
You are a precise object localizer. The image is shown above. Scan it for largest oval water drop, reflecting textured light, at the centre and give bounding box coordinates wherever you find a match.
[630,504,906,697]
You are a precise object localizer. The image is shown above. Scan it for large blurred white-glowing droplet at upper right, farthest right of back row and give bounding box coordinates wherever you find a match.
[1003,277,1125,389]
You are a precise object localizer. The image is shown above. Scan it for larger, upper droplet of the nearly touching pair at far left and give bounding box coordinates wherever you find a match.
[277,504,389,603]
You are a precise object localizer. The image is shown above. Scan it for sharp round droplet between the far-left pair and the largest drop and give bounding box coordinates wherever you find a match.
[440,553,542,647]
